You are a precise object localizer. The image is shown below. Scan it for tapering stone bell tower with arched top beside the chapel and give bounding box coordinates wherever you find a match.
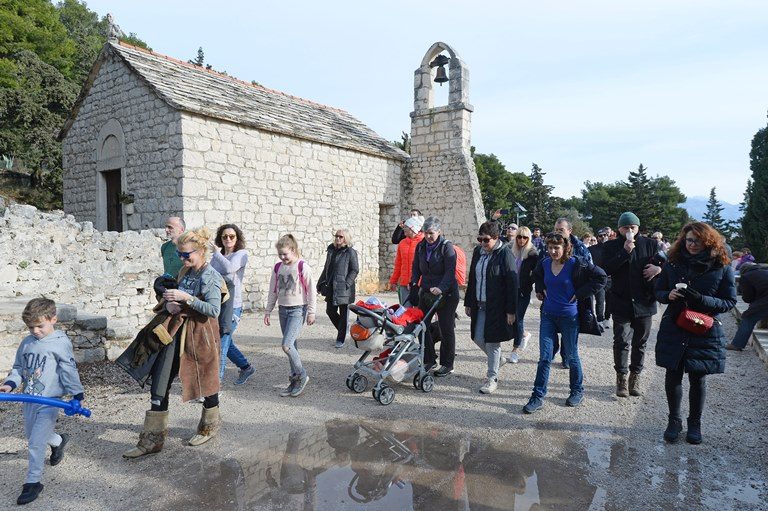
[404,42,485,252]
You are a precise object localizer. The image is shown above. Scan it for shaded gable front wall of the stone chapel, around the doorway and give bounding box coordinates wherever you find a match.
[62,50,182,230]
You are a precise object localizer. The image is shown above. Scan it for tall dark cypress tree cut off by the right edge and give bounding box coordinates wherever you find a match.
[741,118,768,261]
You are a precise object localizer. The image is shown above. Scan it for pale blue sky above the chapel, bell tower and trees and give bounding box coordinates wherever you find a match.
[81,0,768,203]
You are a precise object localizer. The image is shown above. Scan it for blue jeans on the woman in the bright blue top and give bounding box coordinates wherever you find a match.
[533,311,584,398]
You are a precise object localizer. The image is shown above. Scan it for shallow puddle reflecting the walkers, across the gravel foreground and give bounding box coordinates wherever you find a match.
[162,420,766,511]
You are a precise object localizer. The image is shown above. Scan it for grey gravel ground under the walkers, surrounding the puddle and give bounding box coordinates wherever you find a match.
[0,295,768,511]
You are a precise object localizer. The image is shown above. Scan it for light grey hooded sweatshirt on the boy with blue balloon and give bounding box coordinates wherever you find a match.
[5,330,83,401]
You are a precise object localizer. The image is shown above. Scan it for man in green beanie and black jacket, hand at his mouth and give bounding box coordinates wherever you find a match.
[603,211,663,397]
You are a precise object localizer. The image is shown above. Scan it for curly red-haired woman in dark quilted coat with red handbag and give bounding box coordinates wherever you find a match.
[656,222,736,444]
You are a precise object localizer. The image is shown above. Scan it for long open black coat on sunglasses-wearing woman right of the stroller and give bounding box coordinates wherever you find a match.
[464,244,520,342]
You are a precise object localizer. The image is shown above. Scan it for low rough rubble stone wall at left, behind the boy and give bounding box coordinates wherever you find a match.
[0,205,163,339]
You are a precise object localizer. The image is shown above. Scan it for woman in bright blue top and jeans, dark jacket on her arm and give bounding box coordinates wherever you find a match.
[523,233,608,413]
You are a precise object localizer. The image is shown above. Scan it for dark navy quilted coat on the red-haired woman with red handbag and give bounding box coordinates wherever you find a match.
[656,252,736,374]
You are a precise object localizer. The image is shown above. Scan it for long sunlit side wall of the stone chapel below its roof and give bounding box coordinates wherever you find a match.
[180,113,401,307]
